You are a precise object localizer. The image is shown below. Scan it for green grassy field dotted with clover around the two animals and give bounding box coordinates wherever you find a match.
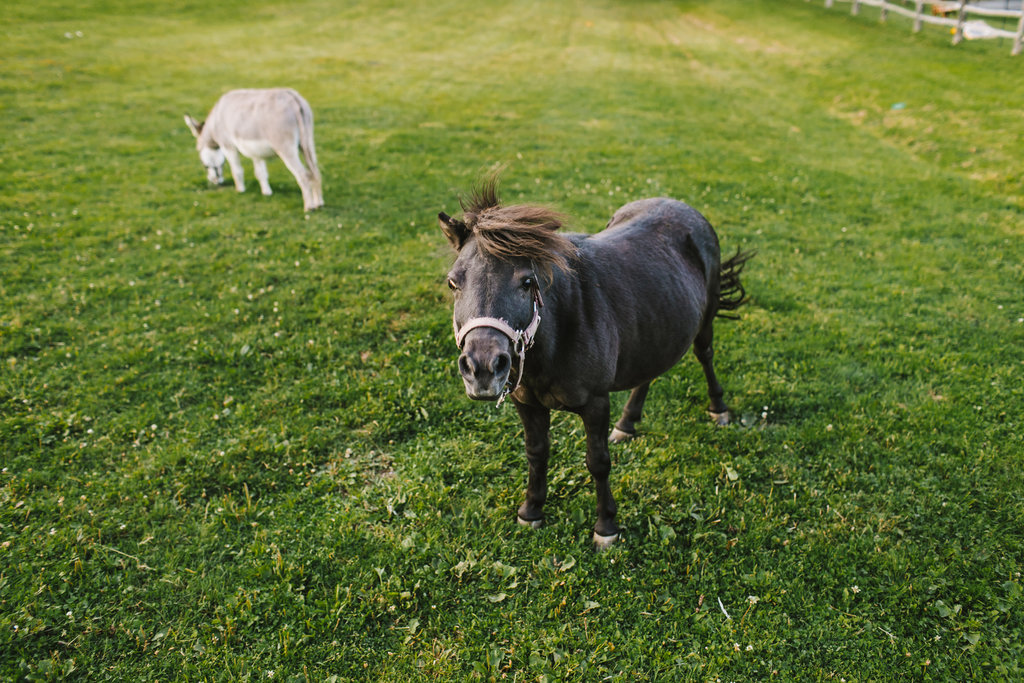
[0,0,1024,681]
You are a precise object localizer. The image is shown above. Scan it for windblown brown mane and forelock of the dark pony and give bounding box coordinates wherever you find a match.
[459,175,575,279]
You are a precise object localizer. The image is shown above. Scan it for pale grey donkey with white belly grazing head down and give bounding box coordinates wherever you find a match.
[185,88,324,211]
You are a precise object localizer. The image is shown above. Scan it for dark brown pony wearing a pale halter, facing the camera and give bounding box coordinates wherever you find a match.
[438,176,753,548]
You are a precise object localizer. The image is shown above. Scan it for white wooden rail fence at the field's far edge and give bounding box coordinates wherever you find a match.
[825,0,1024,54]
